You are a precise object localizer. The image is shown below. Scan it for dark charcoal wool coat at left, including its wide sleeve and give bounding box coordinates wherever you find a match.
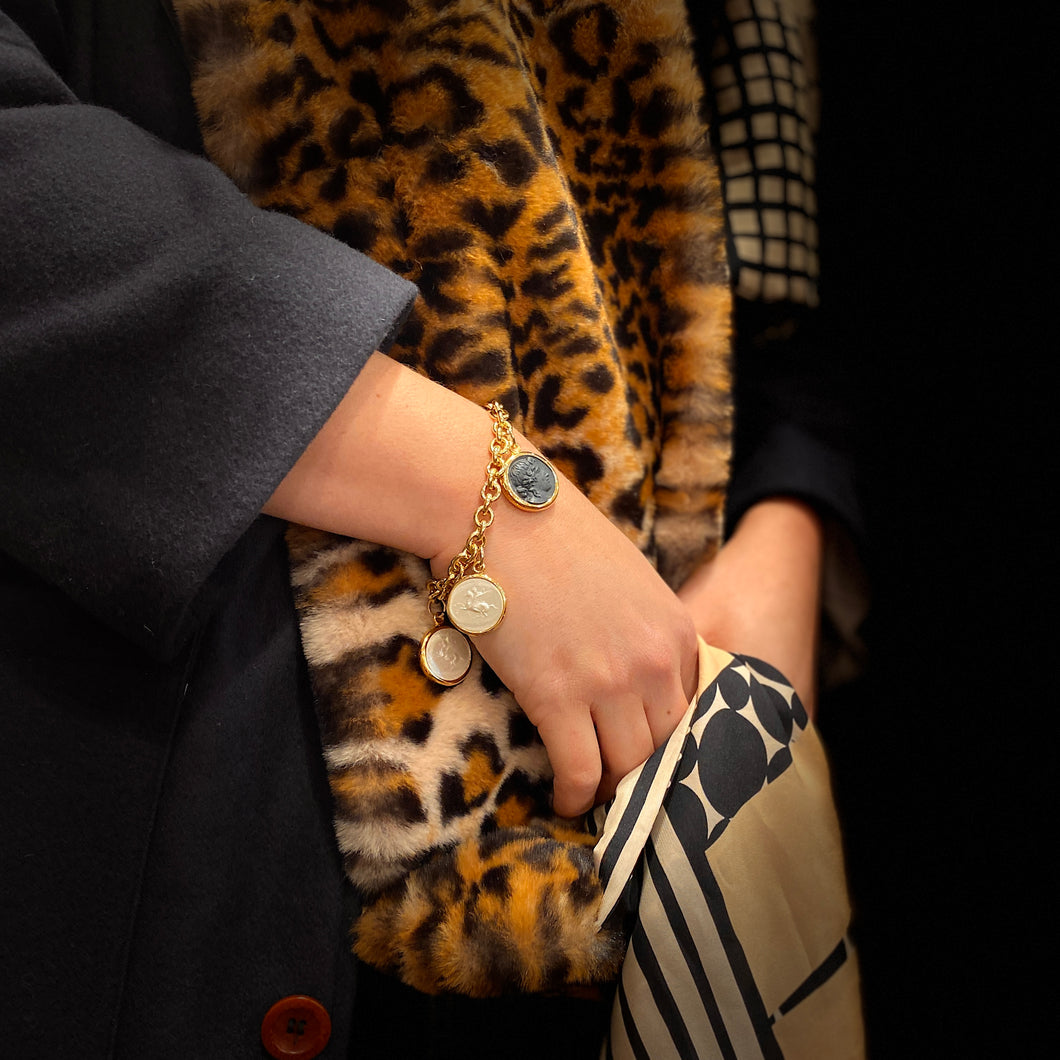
[0,0,414,1060]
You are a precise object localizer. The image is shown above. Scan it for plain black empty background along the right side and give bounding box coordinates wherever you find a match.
[818,0,1047,1060]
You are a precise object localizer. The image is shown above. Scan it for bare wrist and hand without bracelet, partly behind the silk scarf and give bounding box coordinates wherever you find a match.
[677,497,824,718]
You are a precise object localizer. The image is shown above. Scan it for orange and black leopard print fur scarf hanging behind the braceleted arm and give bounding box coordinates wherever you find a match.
[175,0,731,995]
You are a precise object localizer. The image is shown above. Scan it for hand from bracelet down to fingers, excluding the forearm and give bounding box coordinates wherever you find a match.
[451,460,699,816]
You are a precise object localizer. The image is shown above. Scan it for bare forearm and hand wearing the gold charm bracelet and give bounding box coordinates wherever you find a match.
[264,354,697,816]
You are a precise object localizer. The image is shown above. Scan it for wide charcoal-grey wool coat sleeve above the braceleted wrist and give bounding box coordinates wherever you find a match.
[0,14,416,656]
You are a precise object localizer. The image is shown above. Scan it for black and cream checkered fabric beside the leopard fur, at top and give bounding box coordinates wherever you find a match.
[707,0,818,306]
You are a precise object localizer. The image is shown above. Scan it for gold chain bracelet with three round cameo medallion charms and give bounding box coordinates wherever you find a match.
[420,402,559,685]
